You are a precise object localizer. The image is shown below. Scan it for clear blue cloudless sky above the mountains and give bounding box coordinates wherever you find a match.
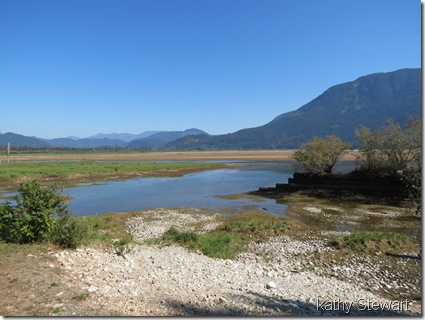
[0,0,421,138]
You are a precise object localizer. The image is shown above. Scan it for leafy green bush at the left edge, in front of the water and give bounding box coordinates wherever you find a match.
[0,180,84,248]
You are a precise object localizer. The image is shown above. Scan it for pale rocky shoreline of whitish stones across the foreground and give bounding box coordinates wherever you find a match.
[55,209,421,316]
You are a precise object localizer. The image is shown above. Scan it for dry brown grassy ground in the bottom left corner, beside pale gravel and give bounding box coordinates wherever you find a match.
[0,242,118,316]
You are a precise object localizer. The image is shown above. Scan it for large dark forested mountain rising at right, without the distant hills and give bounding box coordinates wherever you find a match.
[165,69,422,150]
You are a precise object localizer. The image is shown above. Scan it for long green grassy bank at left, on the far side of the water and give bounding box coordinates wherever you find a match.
[0,161,225,180]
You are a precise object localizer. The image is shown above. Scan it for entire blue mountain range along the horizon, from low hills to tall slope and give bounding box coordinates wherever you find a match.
[0,68,422,150]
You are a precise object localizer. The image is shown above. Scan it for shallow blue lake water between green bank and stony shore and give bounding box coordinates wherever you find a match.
[1,161,352,216]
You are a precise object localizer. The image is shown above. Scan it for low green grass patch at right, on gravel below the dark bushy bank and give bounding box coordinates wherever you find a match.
[330,231,410,252]
